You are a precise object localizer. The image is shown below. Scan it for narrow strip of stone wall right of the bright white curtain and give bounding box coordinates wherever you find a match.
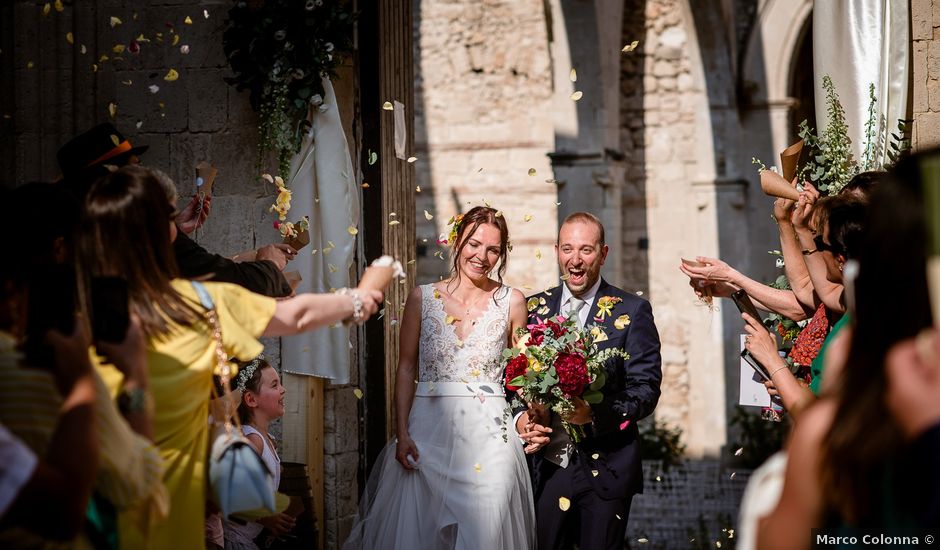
[911,0,940,150]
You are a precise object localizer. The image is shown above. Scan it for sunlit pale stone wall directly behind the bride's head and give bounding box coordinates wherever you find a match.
[414,0,557,293]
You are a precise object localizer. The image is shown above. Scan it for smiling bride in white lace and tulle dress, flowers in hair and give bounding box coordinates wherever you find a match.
[344,207,535,550]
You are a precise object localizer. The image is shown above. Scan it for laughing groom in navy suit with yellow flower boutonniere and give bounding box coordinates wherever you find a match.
[516,212,662,550]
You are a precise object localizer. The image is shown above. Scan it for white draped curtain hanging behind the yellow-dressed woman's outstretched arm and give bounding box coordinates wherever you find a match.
[281,78,359,384]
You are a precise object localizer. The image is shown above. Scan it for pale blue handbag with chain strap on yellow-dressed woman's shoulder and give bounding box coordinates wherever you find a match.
[192,281,276,518]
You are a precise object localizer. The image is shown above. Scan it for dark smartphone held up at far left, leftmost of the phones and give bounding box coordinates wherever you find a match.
[23,264,76,368]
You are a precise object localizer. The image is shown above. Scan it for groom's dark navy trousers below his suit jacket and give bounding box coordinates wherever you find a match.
[535,453,633,550]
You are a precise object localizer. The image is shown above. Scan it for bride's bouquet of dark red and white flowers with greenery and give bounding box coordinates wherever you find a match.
[502,315,629,443]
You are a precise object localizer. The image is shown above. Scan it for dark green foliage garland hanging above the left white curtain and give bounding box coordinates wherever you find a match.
[222,0,355,180]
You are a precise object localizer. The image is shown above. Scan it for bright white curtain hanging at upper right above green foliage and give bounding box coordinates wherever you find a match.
[813,0,911,167]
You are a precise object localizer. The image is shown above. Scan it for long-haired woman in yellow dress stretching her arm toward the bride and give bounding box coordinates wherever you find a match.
[78,166,382,549]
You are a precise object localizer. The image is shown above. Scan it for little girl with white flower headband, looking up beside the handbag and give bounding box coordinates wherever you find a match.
[225,355,294,550]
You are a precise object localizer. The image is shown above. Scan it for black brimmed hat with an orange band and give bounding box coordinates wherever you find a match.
[56,122,147,179]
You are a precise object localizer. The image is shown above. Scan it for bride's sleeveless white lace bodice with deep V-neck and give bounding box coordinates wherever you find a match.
[418,285,510,384]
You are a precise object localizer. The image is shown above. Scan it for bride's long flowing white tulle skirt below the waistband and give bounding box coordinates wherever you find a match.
[343,382,535,550]
